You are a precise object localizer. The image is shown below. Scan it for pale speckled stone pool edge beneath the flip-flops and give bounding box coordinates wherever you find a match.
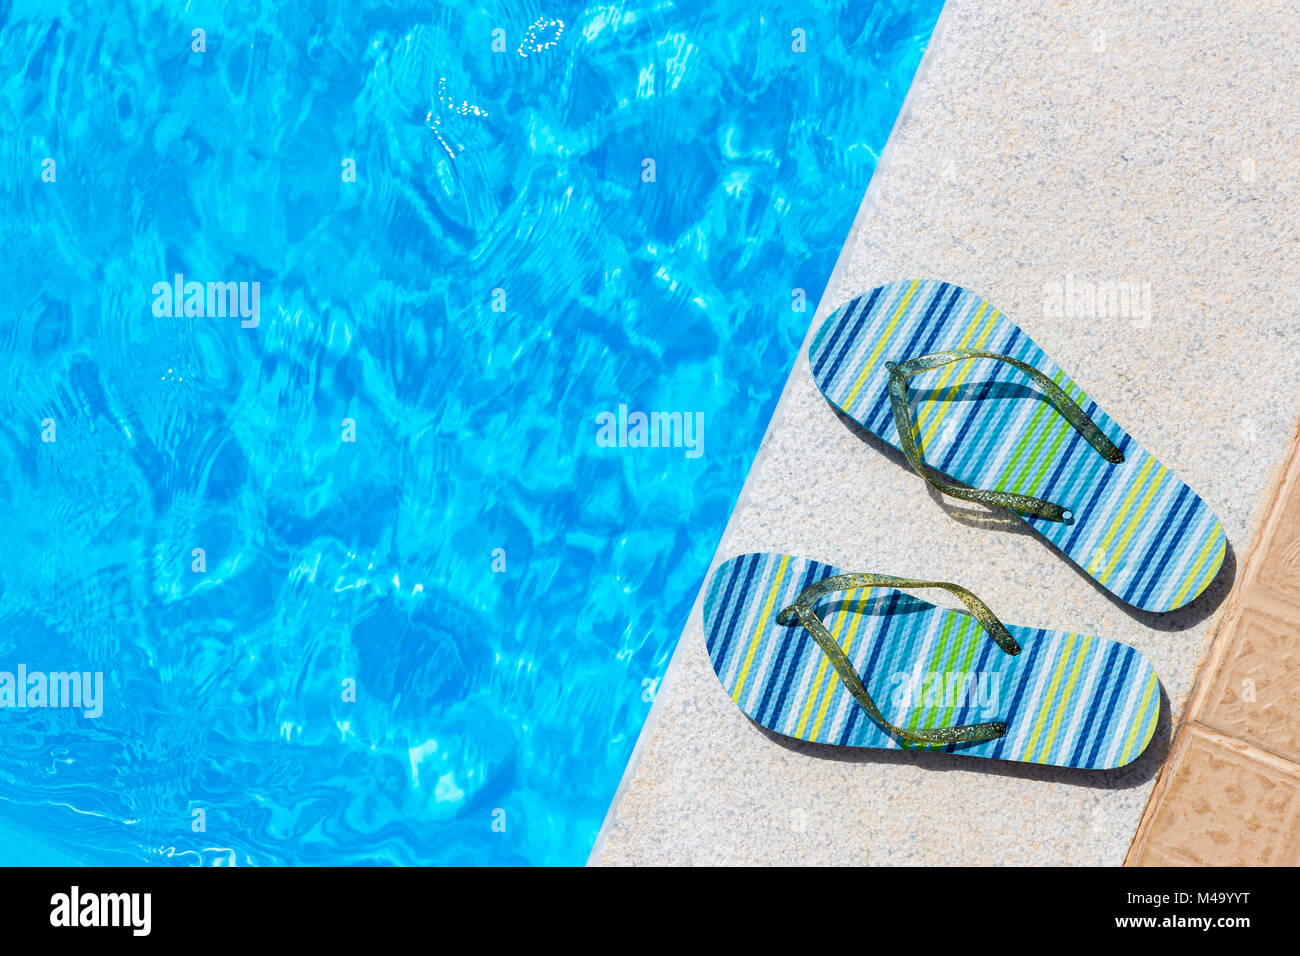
[592,0,1300,865]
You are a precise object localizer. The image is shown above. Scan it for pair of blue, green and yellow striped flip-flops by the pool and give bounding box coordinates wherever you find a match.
[705,280,1227,769]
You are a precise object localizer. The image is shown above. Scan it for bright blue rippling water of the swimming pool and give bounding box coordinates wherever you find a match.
[0,0,941,865]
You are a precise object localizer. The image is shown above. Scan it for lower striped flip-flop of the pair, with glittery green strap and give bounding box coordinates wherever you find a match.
[705,554,1160,769]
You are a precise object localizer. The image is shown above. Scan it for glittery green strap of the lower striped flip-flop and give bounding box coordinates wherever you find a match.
[776,574,1021,744]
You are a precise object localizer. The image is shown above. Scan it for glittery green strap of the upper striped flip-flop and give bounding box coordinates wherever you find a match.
[885,349,1125,522]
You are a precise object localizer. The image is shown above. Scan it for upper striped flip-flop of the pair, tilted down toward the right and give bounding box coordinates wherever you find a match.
[809,280,1227,611]
